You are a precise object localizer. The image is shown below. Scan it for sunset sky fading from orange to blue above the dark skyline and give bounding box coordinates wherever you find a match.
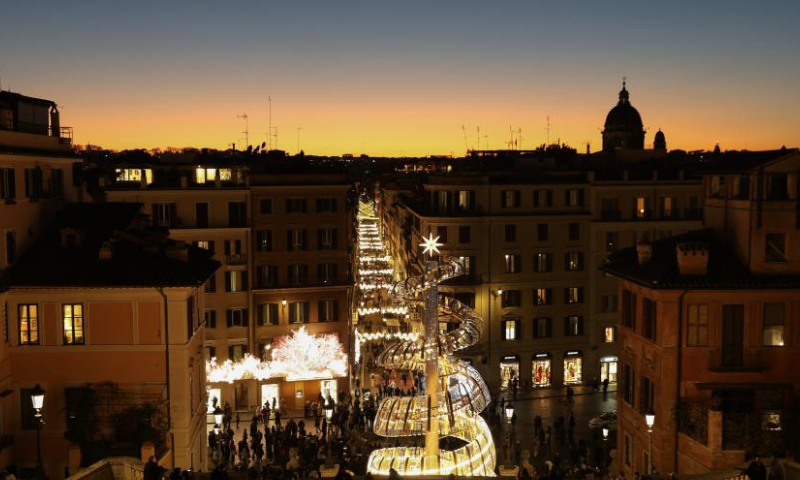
[0,0,800,156]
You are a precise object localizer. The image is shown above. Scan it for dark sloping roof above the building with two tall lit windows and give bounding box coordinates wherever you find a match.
[0,203,220,288]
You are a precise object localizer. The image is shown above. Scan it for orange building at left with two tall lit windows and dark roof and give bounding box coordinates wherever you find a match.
[0,203,219,478]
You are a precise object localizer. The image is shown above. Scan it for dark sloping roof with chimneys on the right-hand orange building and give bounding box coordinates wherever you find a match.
[600,230,800,290]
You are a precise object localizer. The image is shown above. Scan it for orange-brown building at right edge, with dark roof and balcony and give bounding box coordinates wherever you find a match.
[601,151,800,476]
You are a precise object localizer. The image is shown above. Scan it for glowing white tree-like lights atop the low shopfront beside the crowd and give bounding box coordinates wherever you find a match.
[206,327,347,383]
